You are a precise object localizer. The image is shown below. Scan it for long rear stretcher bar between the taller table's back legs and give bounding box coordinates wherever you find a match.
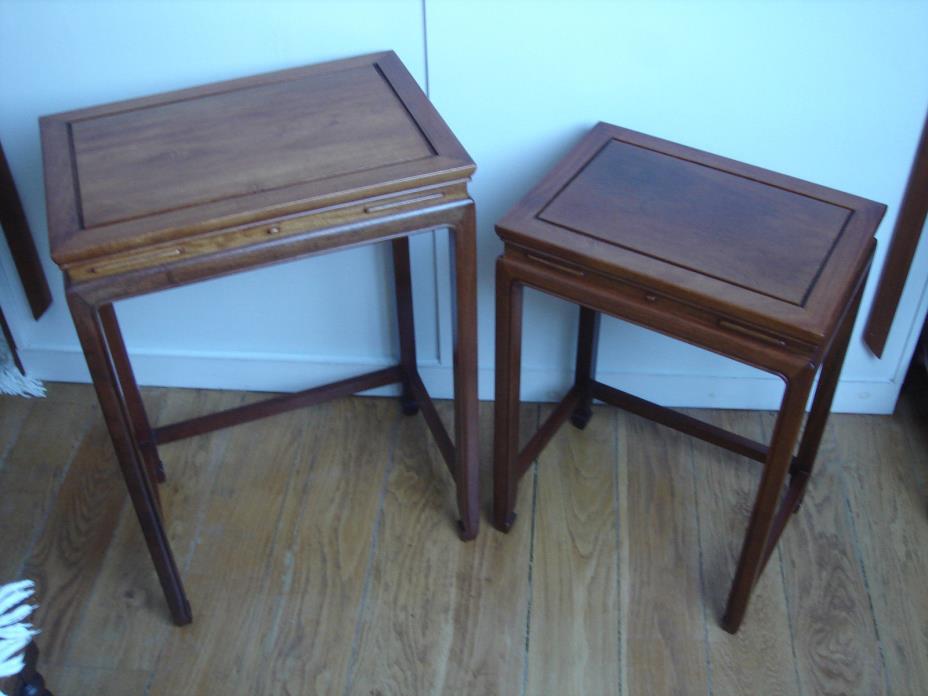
[152,365,403,445]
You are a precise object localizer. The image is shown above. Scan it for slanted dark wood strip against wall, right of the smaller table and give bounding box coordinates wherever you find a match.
[864,115,928,358]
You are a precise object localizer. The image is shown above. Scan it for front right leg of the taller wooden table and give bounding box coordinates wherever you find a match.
[450,203,480,541]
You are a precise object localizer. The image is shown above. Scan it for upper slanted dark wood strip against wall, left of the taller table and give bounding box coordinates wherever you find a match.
[0,145,52,319]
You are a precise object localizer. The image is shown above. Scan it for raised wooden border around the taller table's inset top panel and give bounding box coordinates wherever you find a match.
[39,51,476,266]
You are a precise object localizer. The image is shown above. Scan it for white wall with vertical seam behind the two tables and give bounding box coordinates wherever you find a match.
[0,0,928,412]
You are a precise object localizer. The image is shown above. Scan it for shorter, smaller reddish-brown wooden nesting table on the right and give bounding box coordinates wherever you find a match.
[494,123,885,632]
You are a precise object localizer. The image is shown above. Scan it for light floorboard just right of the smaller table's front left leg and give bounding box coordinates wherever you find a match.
[518,406,619,694]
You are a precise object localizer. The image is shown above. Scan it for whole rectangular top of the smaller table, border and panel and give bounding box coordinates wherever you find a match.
[497,123,885,342]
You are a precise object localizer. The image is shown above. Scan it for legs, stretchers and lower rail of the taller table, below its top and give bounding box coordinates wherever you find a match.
[66,198,479,625]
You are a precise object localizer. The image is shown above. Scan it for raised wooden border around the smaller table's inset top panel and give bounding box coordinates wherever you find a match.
[495,121,886,344]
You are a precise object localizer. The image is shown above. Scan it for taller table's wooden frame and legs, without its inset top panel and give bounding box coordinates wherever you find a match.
[41,52,479,625]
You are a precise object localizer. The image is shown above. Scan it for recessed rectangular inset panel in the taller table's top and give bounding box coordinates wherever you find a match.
[71,65,435,227]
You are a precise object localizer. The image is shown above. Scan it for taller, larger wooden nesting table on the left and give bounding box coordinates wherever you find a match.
[41,52,478,624]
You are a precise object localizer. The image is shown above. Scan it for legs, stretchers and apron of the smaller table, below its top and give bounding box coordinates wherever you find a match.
[493,245,873,633]
